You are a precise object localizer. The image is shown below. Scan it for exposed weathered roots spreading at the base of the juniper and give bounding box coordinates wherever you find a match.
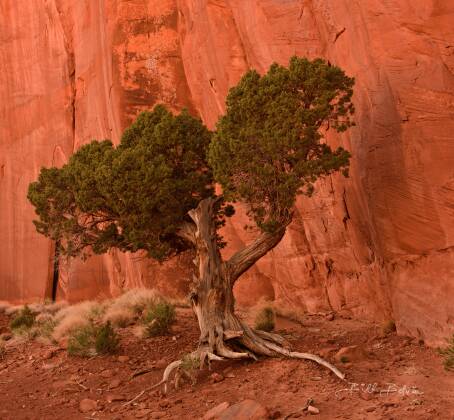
[151,323,345,394]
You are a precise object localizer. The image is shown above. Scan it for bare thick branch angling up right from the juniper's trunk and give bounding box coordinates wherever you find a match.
[226,226,286,284]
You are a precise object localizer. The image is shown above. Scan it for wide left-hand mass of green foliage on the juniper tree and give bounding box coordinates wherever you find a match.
[28,106,213,260]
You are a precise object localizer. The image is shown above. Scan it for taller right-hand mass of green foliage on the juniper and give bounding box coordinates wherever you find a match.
[209,57,354,231]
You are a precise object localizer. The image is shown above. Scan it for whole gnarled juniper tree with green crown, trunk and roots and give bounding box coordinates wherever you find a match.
[28,57,354,388]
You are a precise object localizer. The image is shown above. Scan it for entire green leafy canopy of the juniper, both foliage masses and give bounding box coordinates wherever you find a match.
[28,57,354,259]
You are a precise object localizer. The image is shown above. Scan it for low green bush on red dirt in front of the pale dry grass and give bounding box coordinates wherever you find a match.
[68,322,119,357]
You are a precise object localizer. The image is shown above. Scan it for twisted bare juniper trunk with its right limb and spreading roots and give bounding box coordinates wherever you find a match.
[157,198,344,394]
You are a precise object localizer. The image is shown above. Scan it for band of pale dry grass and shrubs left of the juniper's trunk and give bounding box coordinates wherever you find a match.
[1,289,180,355]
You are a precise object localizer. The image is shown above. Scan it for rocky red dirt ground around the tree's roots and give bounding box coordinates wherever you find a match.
[0,309,454,420]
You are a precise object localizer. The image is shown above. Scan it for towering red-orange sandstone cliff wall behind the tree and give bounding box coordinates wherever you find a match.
[0,0,454,344]
